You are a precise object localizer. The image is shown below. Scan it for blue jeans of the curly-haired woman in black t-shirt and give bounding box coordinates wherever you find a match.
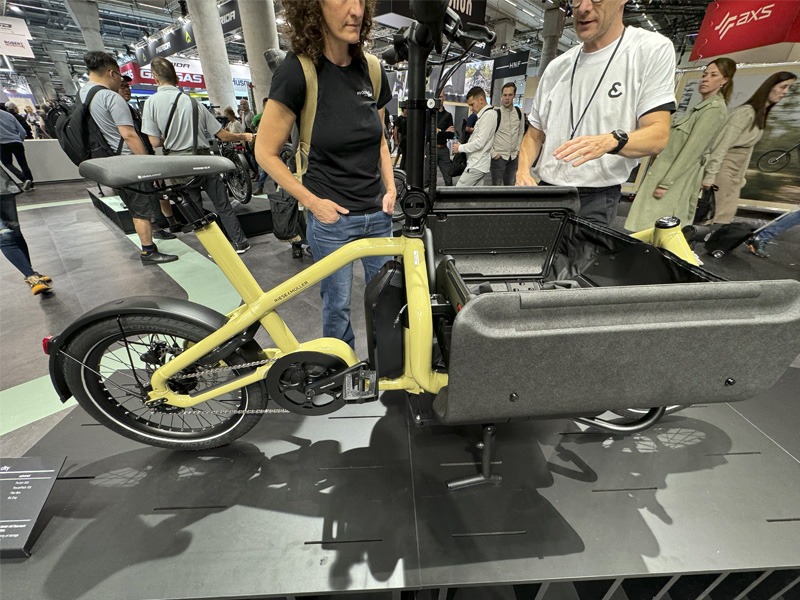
[306,211,392,348]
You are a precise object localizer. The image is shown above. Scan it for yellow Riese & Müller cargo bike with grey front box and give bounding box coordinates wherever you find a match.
[45,0,800,488]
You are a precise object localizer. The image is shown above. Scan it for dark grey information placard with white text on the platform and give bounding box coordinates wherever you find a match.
[0,456,66,558]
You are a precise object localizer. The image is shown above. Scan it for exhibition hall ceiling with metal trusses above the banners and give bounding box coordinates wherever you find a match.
[0,0,709,94]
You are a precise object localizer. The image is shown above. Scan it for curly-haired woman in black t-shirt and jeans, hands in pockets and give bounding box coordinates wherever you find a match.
[256,0,397,347]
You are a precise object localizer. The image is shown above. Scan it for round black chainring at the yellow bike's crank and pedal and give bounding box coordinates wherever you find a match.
[266,351,347,416]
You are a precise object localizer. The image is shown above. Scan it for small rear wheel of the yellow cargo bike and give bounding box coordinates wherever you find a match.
[63,315,268,450]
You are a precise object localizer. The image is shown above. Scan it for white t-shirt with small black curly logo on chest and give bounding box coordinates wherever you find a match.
[528,27,675,187]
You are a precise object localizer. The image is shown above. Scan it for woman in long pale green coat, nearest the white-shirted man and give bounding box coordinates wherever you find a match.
[625,58,736,231]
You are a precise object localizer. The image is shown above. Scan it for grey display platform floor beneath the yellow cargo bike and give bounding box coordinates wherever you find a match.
[0,368,800,600]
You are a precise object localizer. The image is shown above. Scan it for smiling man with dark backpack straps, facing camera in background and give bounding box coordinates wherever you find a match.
[491,83,525,185]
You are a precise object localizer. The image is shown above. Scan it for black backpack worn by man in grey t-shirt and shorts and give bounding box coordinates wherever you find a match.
[56,85,125,165]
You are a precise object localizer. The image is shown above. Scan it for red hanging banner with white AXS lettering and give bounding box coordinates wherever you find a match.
[690,0,800,60]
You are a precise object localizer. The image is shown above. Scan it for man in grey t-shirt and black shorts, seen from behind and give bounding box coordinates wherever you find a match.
[78,51,178,265]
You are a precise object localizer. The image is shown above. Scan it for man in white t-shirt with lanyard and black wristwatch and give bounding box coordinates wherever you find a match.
[516,0,675,225]
